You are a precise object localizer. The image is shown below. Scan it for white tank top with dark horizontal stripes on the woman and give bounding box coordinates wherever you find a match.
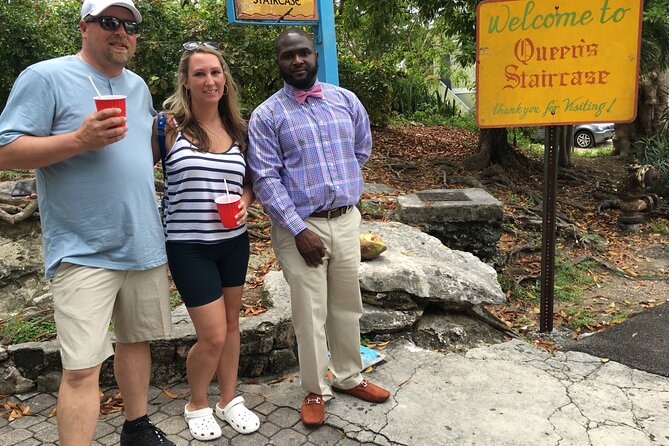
[165,133,246,243]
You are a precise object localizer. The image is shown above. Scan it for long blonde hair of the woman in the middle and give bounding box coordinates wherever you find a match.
[163,45,246,152]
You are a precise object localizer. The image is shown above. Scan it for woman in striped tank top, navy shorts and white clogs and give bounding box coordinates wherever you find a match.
[153,42,260,440]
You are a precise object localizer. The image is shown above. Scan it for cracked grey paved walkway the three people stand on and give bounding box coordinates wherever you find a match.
[0,340,669,446]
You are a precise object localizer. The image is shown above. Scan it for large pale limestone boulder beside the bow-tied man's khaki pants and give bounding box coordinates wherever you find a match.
[359,221,505,308]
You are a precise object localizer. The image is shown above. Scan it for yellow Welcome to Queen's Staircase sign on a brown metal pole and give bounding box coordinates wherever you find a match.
[476,0,643,128]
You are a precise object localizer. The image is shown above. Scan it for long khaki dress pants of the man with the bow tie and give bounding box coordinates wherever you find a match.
[271,206,362,401]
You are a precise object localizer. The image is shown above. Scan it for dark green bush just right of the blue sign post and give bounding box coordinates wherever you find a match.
[339,57,393,127]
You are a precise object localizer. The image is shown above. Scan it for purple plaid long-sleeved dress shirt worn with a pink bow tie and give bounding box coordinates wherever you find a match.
[248,83,372,235]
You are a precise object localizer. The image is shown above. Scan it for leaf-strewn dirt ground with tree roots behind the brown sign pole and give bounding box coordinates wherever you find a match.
[245,125,669,337]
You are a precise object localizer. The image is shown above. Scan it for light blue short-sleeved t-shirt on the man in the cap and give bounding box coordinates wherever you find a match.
[0,56,167,278]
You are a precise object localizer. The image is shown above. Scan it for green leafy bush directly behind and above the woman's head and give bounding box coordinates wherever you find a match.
[129,0,283,117]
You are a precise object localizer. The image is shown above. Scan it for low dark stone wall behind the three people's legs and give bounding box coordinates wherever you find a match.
[0,294,297,395]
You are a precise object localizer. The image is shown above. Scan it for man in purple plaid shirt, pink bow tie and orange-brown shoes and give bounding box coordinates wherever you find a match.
[248,28,390,426]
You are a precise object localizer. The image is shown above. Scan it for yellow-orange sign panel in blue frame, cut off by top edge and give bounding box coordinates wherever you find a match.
[234,0,318,21]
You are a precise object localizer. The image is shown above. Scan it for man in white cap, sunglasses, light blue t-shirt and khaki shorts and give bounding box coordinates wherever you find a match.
[0,0,174,446]
